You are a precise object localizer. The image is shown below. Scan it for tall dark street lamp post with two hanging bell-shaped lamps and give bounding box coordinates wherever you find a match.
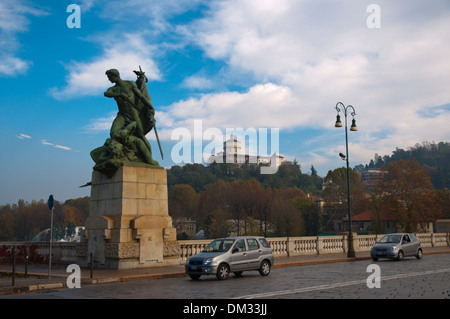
[334,102,358,257]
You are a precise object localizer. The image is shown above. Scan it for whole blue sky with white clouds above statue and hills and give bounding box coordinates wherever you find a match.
[0,0,450,204]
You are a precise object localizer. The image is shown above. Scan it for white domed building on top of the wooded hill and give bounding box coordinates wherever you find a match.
[208,134,284,166]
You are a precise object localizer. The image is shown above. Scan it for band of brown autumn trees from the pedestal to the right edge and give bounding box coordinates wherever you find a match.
[169,159,450,238]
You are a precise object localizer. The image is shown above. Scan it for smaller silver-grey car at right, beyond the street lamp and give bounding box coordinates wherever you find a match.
[370,233,423,261]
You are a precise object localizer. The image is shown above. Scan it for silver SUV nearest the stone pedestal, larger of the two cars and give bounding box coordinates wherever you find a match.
[185,236,274,280]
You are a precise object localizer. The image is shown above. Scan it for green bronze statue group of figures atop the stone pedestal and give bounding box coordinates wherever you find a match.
[91,67,163,177]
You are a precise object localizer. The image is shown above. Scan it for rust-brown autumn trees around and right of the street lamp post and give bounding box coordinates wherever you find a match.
[323,159,450,233]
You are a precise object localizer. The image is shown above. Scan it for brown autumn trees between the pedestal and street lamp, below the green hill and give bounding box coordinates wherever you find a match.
[169,179,320,238]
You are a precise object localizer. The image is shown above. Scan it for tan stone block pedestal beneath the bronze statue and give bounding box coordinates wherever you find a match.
[79,165,179,269]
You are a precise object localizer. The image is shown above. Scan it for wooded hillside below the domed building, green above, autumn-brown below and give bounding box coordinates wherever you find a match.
[167,161,323,237]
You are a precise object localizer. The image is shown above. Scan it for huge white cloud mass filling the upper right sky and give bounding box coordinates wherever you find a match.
[173,0,450,166]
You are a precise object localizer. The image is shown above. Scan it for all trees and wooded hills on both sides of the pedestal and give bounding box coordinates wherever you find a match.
[0,142,450,241]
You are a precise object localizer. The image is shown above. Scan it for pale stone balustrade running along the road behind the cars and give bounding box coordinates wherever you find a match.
[0,233,450,264]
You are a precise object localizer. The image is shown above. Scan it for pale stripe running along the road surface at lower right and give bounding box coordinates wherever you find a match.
[234,268,450,299]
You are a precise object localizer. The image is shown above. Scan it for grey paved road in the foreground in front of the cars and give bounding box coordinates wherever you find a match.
[4,254,450,300]
